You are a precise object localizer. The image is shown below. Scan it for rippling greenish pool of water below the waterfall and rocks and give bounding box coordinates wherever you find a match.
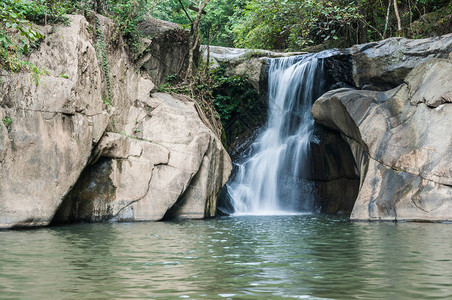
[0,215,452,299]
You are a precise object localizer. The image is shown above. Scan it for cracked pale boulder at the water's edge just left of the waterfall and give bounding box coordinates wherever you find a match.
[55,86,231,222]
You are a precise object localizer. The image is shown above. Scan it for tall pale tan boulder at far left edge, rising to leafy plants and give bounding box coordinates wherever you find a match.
[0,16,108,228]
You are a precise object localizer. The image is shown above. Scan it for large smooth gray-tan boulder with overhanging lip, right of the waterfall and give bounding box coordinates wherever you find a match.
[312,59,452,221]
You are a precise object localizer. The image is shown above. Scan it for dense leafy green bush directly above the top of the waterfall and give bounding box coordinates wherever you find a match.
[233,0,360,50]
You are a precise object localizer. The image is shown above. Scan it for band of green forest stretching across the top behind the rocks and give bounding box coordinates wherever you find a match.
[0,0,452,57]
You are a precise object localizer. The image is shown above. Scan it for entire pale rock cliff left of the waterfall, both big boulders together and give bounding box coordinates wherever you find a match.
[0,16,231,228]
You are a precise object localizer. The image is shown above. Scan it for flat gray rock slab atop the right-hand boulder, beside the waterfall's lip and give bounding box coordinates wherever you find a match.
[352,34,452,91]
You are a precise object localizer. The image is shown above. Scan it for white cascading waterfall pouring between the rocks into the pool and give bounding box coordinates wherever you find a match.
[227,52,328,215]
